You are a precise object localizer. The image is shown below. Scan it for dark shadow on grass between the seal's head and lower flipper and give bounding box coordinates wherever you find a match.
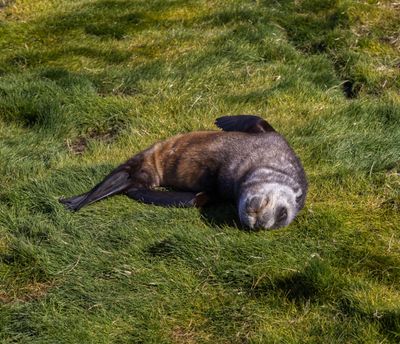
[200,203,239,229]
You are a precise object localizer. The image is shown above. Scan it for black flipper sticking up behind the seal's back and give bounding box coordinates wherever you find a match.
[215,115,275,133]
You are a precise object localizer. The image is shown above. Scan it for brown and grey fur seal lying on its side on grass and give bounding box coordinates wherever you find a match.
[60,115,307,229]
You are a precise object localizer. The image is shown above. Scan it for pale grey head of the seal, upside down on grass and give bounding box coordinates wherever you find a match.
[238,183,304,229]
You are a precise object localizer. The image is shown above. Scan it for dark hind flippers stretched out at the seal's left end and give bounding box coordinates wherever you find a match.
[60,170,132,211]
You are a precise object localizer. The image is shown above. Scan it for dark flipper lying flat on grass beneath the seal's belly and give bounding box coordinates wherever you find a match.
[126,189,210,208]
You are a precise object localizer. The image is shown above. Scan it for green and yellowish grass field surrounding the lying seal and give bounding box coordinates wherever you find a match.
[0,0,400,343]
